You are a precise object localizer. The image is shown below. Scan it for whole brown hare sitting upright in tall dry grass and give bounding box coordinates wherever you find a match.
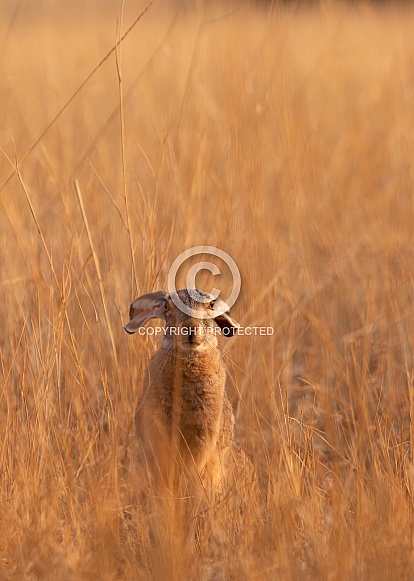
[127,290,250,493]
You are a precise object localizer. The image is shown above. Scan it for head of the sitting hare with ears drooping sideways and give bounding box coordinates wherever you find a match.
[124,289,239,350]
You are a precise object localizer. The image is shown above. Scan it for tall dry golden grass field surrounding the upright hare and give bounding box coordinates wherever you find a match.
[0,0,414,581]
